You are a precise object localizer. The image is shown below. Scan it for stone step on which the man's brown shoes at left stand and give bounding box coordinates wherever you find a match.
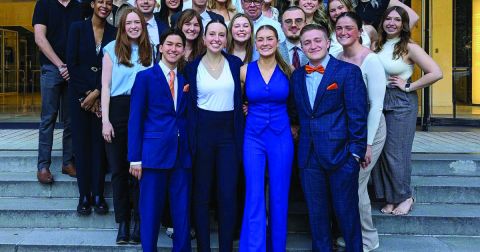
[0,172,480,204]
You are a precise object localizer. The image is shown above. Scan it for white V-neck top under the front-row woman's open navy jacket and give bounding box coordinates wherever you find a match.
[197,60,235,112]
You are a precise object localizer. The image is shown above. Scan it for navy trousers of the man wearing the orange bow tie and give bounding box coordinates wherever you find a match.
[300,150,363,252]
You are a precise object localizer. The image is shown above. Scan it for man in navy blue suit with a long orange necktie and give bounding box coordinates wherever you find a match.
[128,30,192,252]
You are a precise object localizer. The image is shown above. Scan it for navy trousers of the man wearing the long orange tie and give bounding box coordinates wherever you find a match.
[139,168,192,252]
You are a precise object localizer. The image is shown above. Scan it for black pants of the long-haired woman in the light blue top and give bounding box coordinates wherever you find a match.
[105,95,139,223]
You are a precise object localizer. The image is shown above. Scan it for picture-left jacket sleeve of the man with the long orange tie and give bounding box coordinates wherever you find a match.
[128,72,148,162]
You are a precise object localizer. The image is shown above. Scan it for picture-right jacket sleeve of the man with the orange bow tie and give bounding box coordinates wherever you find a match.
[344,66,368,157]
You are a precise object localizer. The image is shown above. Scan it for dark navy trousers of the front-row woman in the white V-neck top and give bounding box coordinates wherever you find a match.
[192,110,239,252]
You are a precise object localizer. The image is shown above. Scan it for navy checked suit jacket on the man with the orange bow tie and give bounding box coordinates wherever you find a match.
[290,56,368,170]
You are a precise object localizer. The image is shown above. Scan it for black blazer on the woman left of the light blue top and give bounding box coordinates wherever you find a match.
[67,18,117,96]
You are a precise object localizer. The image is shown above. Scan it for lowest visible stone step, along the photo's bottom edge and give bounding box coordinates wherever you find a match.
[0,228,480,252]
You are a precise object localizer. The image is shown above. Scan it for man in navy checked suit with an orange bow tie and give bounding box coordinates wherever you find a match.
[291,24,368,252]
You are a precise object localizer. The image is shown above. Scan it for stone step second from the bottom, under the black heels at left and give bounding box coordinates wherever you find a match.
[0,198,480,235]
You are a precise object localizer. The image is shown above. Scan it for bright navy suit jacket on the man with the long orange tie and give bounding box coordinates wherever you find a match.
[128,64,192,169]
